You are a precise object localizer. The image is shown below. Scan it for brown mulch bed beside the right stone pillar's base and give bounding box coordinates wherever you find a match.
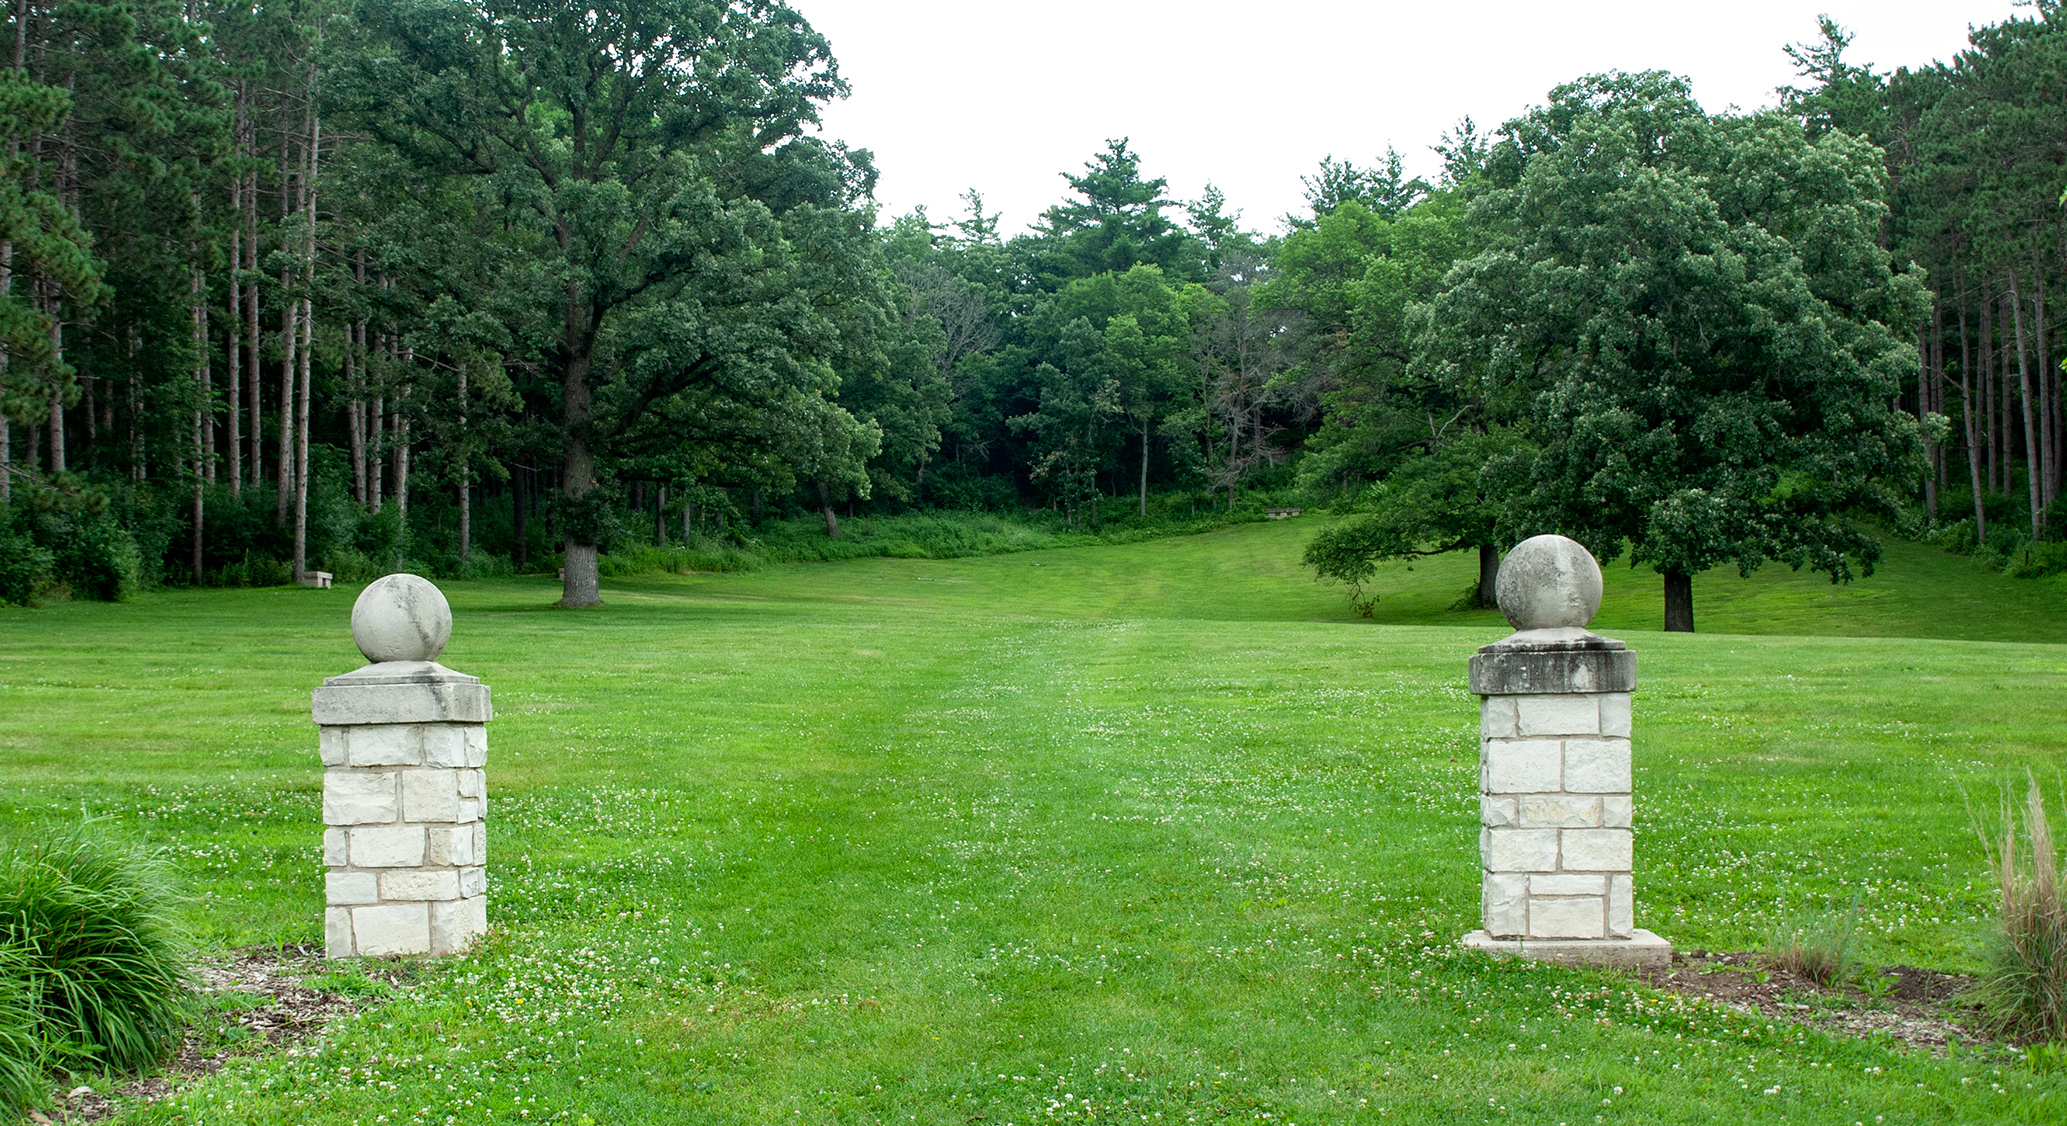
[1641,950,1993,1056]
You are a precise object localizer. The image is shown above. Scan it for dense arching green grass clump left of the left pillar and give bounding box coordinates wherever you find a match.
[0,822,192,1070]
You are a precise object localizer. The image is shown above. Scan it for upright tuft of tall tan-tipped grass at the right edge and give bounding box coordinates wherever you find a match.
[1974,775,2067,1041]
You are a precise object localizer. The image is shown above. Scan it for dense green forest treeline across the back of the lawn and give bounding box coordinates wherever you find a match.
[0,0,2067,628]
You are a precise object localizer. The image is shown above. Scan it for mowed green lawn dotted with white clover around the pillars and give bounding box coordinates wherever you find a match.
[0,521,2067,1126]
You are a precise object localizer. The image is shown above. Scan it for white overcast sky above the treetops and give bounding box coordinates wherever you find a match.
[810,0,2015,231]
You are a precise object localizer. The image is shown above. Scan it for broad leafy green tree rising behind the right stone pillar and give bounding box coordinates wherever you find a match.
[1416,72,1926,630]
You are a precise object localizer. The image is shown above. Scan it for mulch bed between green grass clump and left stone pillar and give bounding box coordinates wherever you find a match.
[29,946,401,1126]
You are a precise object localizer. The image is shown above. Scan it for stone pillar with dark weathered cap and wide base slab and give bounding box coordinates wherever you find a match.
[1463,535,1672,967]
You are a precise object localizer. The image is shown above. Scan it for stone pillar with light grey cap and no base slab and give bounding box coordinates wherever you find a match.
[314,574,492,959]
